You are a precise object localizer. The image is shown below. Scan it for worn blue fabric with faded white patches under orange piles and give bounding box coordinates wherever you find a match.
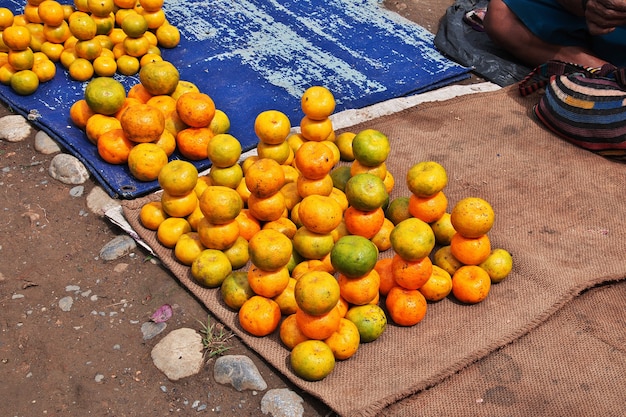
[0,0,469,198]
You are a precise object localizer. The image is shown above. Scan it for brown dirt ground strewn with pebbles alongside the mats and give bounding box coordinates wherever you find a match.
[0,0,468,417]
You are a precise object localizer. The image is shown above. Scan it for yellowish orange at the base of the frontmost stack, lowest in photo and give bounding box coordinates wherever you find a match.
[289,340,335,381]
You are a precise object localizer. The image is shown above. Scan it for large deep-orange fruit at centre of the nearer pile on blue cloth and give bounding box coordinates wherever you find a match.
[120,104,165,143]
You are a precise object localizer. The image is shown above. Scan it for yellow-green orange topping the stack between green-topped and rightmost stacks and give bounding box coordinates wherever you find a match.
[389,217,435,261]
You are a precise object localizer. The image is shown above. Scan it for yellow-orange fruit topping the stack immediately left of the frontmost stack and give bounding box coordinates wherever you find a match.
[248,229,293,271]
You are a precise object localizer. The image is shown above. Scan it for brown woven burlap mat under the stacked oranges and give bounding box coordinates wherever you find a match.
[123,88,626,416]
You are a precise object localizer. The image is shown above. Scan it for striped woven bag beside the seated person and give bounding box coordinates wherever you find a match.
[519,61,626,161]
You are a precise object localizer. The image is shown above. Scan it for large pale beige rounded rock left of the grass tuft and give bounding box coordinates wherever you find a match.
[151,328,204,381]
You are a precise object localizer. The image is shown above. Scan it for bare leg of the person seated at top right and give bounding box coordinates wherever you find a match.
[483,0,606,67]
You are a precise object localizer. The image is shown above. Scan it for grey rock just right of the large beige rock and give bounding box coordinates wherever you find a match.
[213,355,267,391]
